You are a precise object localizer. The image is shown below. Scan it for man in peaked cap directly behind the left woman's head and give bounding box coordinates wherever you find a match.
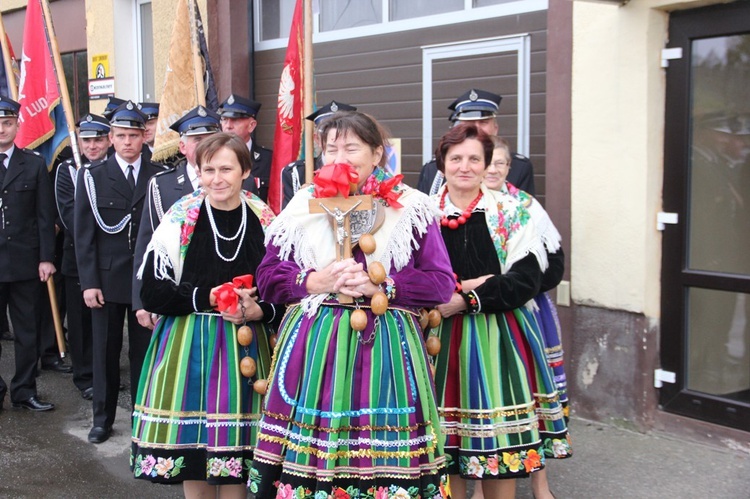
[219,94,273,202]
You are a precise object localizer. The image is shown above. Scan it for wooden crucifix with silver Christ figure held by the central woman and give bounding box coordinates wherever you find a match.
[309,195,372,303]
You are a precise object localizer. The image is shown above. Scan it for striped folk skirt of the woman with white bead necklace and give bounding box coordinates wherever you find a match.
[130,314,270,485]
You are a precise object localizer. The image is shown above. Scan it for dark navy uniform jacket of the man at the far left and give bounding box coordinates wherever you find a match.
[0,147,55,282]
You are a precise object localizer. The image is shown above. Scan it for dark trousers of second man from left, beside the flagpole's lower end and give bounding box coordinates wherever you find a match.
[65,276,94,391]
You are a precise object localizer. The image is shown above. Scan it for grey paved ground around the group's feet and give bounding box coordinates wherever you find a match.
[0,332,750,499]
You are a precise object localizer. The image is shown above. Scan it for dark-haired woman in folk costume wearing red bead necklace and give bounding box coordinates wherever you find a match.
[428,123,569,498]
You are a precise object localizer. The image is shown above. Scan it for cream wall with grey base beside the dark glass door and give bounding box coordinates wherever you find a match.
[568,0,748,438]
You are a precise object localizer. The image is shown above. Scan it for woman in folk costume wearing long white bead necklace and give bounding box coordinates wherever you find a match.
[131,133,283,498]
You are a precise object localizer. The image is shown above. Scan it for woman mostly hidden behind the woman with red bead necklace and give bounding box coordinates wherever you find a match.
[474,137,570,499]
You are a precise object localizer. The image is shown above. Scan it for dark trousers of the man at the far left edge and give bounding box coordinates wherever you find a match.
[0,279,42,402]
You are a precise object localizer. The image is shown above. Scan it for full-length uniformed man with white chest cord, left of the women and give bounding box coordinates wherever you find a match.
[74,101,163,443]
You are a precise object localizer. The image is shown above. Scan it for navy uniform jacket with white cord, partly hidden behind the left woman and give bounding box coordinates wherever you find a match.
[132,160,193,310]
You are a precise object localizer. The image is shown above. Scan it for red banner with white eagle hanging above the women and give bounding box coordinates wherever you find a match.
[268,0,305,213]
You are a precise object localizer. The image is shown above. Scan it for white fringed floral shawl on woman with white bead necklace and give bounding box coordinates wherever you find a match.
[138,189,274,284]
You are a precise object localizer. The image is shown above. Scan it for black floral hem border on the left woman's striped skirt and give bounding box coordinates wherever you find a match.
[130,442,253,485]
